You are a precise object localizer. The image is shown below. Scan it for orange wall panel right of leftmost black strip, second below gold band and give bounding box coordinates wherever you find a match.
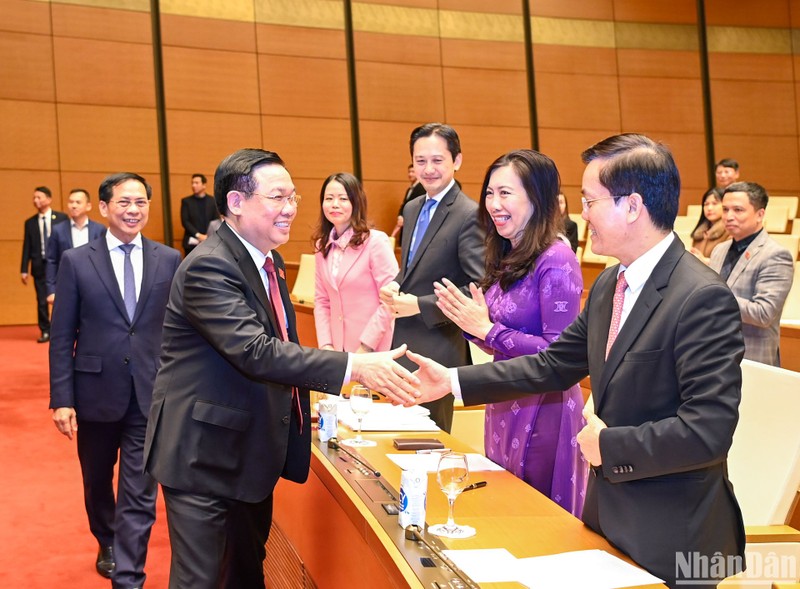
[163,47,259,114]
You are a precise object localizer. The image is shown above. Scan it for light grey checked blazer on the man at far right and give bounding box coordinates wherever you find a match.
[710,229,794,366]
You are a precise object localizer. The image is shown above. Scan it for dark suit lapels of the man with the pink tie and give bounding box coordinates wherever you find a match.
[592,236,686,411]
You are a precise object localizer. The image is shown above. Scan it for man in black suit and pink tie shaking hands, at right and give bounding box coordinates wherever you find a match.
[409,134,745,587]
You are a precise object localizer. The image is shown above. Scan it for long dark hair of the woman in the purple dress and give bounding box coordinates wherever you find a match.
[478,149,562,290]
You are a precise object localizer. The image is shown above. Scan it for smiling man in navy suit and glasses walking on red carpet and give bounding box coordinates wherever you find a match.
[50,172,181,589]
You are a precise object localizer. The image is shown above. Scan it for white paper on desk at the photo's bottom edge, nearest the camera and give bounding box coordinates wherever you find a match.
[517,550,664,589]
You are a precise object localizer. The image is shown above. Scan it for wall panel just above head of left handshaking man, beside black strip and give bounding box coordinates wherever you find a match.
[167,110,262,173]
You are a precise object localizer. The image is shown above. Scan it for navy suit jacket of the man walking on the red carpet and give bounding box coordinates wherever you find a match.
[50,237,181,421]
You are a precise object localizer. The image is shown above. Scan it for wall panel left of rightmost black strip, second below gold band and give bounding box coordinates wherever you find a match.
[619,77,703,133]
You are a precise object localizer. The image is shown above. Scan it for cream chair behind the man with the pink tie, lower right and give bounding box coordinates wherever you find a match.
[720,360,800,589]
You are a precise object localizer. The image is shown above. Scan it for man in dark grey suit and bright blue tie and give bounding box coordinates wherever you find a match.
[381,123,485,432]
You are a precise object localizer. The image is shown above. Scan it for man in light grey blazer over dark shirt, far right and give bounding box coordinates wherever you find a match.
[710,182,794,366]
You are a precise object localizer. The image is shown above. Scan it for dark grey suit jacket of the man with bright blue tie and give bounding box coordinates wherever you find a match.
[392,184,485,369]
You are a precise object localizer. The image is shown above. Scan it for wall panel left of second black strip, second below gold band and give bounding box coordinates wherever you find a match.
[258,55,349,119]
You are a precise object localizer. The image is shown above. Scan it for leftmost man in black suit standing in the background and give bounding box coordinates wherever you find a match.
[22,186,67,344]
